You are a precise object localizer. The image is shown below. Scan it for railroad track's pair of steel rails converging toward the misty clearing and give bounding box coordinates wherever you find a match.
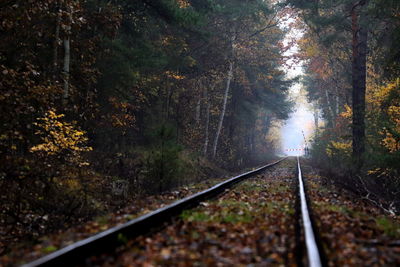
[24,159,324,267]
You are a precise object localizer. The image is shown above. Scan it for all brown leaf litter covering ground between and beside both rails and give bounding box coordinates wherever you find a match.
[0,160,400,266]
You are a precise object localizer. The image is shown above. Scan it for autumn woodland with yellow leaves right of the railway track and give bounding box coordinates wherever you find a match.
[288,0,400,213]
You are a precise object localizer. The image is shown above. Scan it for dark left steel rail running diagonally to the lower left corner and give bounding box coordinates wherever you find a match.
[22,158,286,267]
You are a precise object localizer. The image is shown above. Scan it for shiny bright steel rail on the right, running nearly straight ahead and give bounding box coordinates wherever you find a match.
[297,157,322,267]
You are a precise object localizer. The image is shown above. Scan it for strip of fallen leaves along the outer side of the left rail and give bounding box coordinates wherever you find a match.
[0,178,228,266]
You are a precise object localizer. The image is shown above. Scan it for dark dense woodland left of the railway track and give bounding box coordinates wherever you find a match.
[0,0,292,247]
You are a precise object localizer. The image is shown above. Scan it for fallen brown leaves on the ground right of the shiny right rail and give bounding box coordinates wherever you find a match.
[302,160,400,266]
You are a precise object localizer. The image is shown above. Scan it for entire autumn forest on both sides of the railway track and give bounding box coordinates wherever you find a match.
[0,0,400,264]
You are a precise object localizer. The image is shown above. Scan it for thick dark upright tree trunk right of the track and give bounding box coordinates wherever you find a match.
[351,0,368,171]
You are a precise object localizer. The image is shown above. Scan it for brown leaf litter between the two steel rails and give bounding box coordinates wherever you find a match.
[86,161,296,266]
